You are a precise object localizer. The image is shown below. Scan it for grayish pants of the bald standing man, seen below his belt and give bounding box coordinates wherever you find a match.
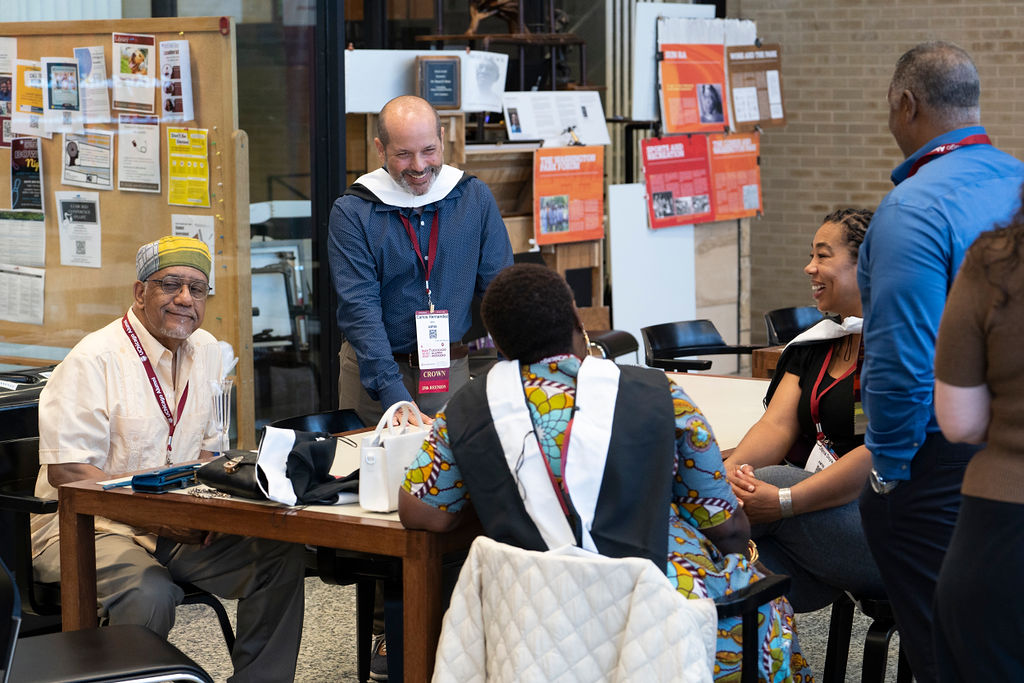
[338,342,469,427]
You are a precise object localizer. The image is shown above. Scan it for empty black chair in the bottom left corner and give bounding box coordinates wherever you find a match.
[0,562,213,683]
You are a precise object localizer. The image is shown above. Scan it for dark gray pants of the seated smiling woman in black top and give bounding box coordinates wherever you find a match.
[751,465,886,612]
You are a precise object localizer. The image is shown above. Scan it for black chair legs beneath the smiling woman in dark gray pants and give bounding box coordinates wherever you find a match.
[822,593,913,683]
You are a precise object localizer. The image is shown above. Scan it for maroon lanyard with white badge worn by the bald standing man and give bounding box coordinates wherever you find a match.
[398,211,452,393]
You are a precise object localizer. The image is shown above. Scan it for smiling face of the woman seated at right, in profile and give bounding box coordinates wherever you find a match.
[804,223,861,317]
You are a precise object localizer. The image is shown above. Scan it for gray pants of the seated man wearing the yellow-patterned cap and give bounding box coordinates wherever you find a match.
[34,533,305,683]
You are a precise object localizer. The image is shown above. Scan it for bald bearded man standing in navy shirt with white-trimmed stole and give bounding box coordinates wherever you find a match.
[328,95,512,424]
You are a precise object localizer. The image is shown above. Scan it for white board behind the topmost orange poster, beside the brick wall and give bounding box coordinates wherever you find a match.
[633,2,715,121]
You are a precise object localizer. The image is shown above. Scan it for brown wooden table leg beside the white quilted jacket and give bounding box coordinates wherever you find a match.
[401,542,442,683]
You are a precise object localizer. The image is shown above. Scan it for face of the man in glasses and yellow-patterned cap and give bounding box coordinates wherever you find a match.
[133,265,208,351]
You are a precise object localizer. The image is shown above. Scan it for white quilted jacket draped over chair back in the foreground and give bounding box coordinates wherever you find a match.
[433,537,718,683]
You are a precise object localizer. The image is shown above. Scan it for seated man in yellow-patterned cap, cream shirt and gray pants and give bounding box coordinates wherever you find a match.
[32,237,304,681]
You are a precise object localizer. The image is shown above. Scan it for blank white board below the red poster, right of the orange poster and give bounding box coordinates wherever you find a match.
[608,182,697,365]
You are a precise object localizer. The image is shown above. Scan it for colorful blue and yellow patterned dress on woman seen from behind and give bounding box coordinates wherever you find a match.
[404,355,813,683]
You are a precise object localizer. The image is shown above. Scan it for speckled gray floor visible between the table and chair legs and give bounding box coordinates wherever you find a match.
[170,579,898,683]
